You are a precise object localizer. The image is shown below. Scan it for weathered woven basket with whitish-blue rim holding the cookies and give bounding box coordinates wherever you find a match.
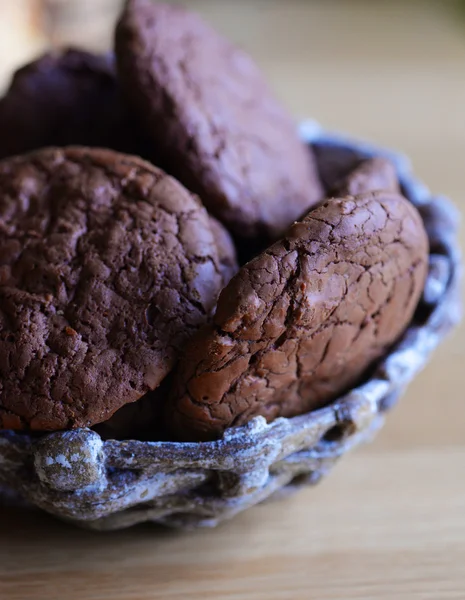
[0,122,460,530]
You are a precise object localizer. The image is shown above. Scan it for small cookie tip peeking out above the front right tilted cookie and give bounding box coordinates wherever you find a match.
[334,157,400,197]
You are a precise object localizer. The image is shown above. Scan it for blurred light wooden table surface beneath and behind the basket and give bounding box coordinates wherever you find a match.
[0,0,465,600]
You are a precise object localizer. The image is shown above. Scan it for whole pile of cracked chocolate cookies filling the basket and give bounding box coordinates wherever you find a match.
[0,0,428,441]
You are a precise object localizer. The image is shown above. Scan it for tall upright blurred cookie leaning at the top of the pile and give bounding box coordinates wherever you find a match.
[116,0,323,239]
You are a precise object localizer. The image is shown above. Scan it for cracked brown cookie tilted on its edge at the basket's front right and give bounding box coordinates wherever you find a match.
[168,192,428,440]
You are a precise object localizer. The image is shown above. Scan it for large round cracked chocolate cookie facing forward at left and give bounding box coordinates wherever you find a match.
[0,148,222,430]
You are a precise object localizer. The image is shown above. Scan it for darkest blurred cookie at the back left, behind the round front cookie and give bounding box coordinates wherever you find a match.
[0,49,144,158]
